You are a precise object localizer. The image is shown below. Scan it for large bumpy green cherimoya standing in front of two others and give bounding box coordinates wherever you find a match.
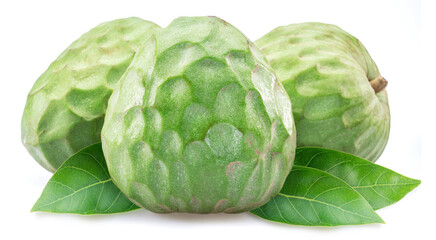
[102,17,296,213]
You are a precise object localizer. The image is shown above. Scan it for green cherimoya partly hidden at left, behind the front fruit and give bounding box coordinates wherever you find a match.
[21,18,160,172]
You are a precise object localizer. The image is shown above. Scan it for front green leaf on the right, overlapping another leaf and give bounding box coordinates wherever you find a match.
[252,166,383,226]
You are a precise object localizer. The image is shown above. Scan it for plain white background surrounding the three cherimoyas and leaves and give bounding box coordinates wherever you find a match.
[0,0,436,240]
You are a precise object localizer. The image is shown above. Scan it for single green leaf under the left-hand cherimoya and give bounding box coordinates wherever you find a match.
[32,143,138,215]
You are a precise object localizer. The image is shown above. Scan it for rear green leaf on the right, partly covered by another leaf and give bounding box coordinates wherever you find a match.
[294,147,421,210]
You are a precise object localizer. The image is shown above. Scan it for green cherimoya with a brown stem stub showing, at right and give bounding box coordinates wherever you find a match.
[255,23,390,162]
